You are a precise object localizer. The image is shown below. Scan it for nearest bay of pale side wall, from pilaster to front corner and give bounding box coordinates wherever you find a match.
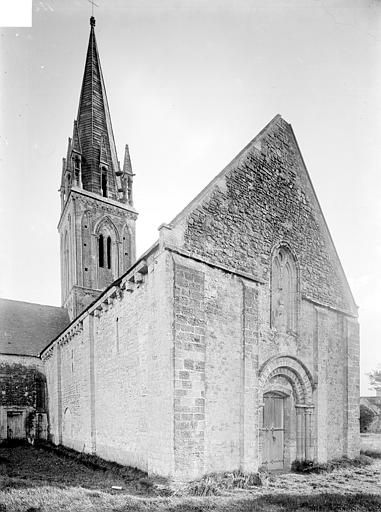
[94,252,173,475]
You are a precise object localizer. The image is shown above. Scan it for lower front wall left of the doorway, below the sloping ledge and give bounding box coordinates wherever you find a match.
[174,255,259,479]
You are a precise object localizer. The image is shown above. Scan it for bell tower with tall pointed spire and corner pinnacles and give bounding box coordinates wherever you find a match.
[58,16,137,319]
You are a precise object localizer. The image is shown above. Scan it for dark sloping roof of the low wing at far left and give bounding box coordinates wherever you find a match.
[0,299,70,356]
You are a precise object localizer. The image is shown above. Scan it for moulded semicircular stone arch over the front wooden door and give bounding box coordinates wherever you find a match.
[259,355,313,405]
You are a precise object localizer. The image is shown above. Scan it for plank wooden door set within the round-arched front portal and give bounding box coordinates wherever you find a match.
[262,395,284,469]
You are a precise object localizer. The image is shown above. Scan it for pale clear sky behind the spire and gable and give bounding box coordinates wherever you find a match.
[0,0,381,395]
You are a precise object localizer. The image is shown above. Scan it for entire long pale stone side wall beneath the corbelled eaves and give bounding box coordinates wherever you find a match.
[43,247,173,475]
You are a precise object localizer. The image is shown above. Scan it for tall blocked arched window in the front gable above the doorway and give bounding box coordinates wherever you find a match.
[270,247,298,332]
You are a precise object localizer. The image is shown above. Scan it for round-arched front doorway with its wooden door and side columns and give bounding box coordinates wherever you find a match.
[259,355,315,470]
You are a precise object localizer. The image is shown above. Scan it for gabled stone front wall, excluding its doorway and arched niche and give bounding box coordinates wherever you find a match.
[162,116,359,475]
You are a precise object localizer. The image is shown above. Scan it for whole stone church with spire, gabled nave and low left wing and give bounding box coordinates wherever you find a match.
[0,18,359,479]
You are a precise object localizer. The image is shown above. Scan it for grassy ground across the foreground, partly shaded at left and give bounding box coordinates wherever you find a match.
[0,445,381,512]
